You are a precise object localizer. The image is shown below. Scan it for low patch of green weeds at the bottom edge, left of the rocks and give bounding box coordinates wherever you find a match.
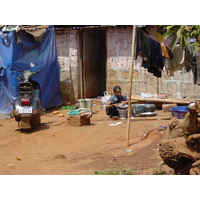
[91,166,137,175]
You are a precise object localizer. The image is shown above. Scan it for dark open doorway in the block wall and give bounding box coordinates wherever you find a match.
[82,30,106,98]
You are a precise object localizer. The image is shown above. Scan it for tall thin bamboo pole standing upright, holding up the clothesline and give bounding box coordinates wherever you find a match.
[126,25,136,146]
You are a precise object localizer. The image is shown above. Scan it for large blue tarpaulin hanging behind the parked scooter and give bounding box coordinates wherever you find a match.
[0,26,61,114]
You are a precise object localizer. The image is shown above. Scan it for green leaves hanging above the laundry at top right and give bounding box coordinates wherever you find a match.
[164,25,200,51]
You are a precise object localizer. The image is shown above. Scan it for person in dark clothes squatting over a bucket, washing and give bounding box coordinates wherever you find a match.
[105,85,127,118]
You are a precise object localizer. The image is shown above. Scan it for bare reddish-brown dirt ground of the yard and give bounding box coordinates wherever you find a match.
[0,101,170,175]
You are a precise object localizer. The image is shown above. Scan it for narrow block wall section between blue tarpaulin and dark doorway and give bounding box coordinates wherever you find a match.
[56,30,79,103]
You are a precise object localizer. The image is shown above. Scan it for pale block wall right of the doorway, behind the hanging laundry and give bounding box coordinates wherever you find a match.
[106,26,200,98]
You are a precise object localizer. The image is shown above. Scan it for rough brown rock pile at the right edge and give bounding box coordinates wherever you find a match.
[159,102,200,175]
